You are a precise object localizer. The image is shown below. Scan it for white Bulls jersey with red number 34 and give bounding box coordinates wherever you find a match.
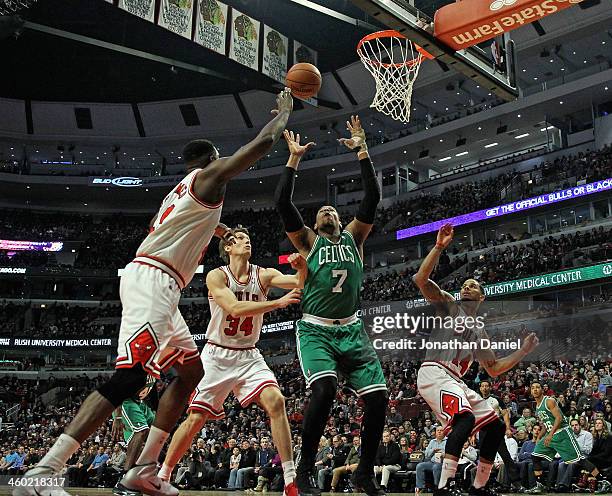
[206,264,267,348]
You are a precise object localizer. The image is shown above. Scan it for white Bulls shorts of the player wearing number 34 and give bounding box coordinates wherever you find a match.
[188,341,278,419]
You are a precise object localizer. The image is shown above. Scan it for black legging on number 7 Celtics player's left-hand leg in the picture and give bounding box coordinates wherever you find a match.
[297,377,338,474]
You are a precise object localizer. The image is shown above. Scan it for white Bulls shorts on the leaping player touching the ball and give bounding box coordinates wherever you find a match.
[116,262,199,377]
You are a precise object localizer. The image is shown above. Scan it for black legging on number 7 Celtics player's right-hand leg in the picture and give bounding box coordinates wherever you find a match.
[357,391,389,475]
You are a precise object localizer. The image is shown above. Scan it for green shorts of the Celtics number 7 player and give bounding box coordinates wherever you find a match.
[296,319,387,396]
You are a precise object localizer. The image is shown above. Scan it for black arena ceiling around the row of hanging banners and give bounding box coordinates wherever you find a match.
[0,0,375,102]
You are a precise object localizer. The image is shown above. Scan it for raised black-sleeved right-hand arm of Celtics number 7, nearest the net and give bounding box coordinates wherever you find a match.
[338,115,381,248]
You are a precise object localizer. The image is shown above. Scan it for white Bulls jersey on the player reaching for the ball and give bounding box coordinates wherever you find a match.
[134,169,223,288]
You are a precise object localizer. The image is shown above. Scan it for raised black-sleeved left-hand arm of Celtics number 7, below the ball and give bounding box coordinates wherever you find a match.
[274,131,317,257]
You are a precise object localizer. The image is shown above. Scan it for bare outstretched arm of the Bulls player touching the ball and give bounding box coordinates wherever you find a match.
[194,88,293,201]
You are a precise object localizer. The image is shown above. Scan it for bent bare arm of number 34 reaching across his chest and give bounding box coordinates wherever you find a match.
[206,270,301,317]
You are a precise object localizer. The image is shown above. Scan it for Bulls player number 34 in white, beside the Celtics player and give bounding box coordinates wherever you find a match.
[159,227,308,496]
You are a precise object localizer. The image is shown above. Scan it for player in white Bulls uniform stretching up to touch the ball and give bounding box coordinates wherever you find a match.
[13,88,293,496]
